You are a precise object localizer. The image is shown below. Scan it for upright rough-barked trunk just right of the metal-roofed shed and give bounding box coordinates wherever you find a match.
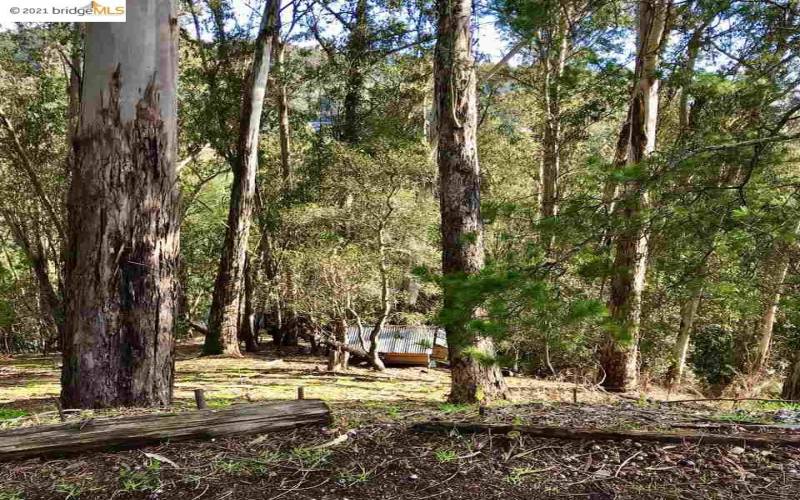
[434,0,508,403]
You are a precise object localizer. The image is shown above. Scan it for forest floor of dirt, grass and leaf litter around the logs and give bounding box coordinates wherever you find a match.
[0,343,800,500]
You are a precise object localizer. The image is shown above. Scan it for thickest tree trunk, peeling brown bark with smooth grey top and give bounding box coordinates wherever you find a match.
[61,0,180,408]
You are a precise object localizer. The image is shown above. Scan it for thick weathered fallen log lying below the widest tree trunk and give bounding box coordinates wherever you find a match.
[0,399,331,461]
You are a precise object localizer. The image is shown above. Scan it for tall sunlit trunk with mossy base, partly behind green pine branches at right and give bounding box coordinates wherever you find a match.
[600,0,671,391]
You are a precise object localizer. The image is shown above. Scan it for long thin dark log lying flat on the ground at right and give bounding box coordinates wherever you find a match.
[412,421,800,447]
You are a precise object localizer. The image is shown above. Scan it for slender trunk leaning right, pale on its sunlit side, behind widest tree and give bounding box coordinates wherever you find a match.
[203,0,280,357]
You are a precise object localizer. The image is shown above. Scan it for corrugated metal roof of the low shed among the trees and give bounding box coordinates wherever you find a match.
[347,325,447,354]
